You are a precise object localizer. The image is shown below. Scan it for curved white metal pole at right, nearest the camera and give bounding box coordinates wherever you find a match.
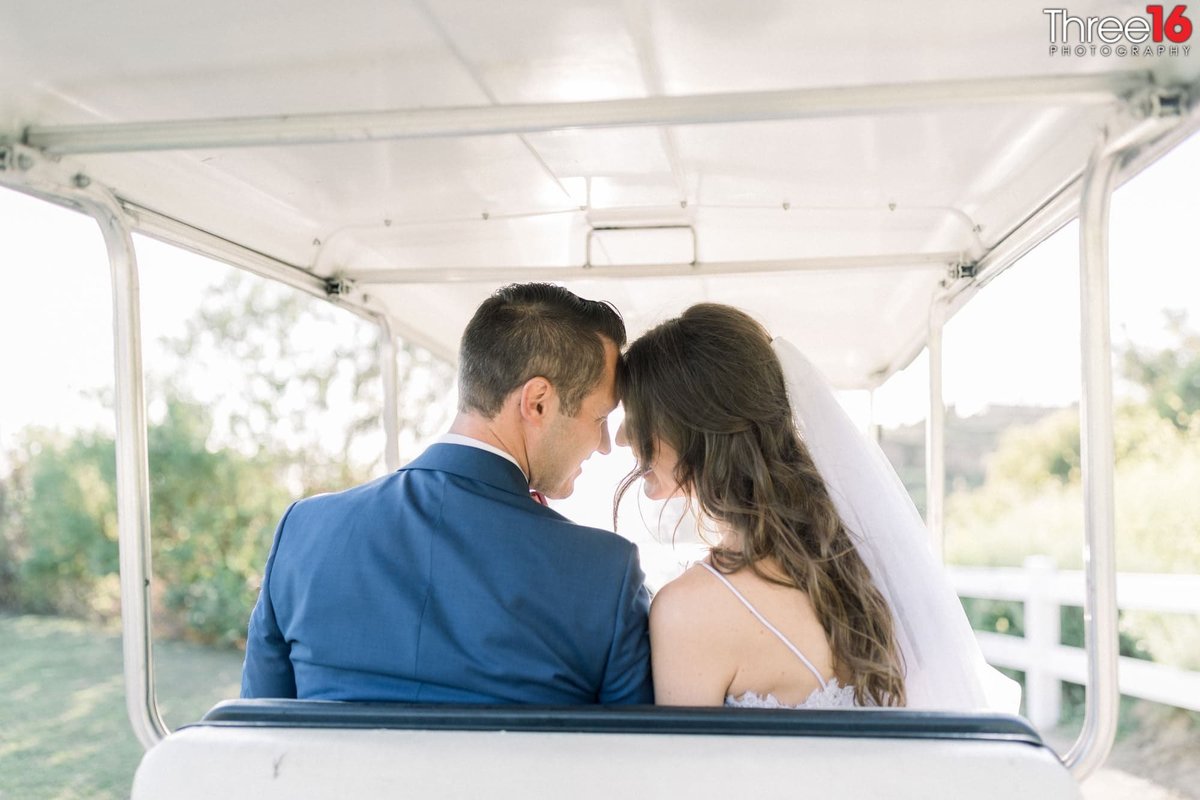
[1063,136,1124,781]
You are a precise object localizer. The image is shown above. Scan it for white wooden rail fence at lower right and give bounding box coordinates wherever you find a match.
[948,555,1200,728]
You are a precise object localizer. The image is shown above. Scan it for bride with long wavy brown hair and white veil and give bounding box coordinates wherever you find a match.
[617,303,1016,711]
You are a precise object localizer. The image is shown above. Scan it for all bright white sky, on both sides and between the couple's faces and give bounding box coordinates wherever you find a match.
[0,137,1200,544]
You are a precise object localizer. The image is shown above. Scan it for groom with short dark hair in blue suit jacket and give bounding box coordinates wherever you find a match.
[241,283,653,705]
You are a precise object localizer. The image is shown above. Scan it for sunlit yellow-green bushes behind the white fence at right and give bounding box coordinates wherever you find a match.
[946,314,1200,571]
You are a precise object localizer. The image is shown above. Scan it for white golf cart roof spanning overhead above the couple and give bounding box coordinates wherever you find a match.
[0,0,1200,389]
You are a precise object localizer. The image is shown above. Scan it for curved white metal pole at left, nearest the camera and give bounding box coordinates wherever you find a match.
[76,194,168,750]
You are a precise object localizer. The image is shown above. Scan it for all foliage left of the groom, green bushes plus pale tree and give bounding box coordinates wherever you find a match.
[0,268,451,644]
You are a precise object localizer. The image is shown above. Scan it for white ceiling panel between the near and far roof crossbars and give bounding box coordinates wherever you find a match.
[79,101,1105,276]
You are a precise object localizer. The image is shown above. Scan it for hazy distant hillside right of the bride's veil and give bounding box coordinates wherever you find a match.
[880,405,1061,515]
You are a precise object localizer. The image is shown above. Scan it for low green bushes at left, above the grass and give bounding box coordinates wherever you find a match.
[4,398,288,644]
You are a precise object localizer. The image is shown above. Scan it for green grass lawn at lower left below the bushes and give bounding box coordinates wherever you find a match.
[0,615,242,800]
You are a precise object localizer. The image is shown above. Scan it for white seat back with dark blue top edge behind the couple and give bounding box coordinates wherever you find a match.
[133,700,1080,800]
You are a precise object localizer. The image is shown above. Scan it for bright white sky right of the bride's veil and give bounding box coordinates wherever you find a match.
[875,130,1200,426]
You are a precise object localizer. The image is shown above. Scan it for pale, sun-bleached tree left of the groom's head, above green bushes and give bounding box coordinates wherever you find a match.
[162,272,452,494]
